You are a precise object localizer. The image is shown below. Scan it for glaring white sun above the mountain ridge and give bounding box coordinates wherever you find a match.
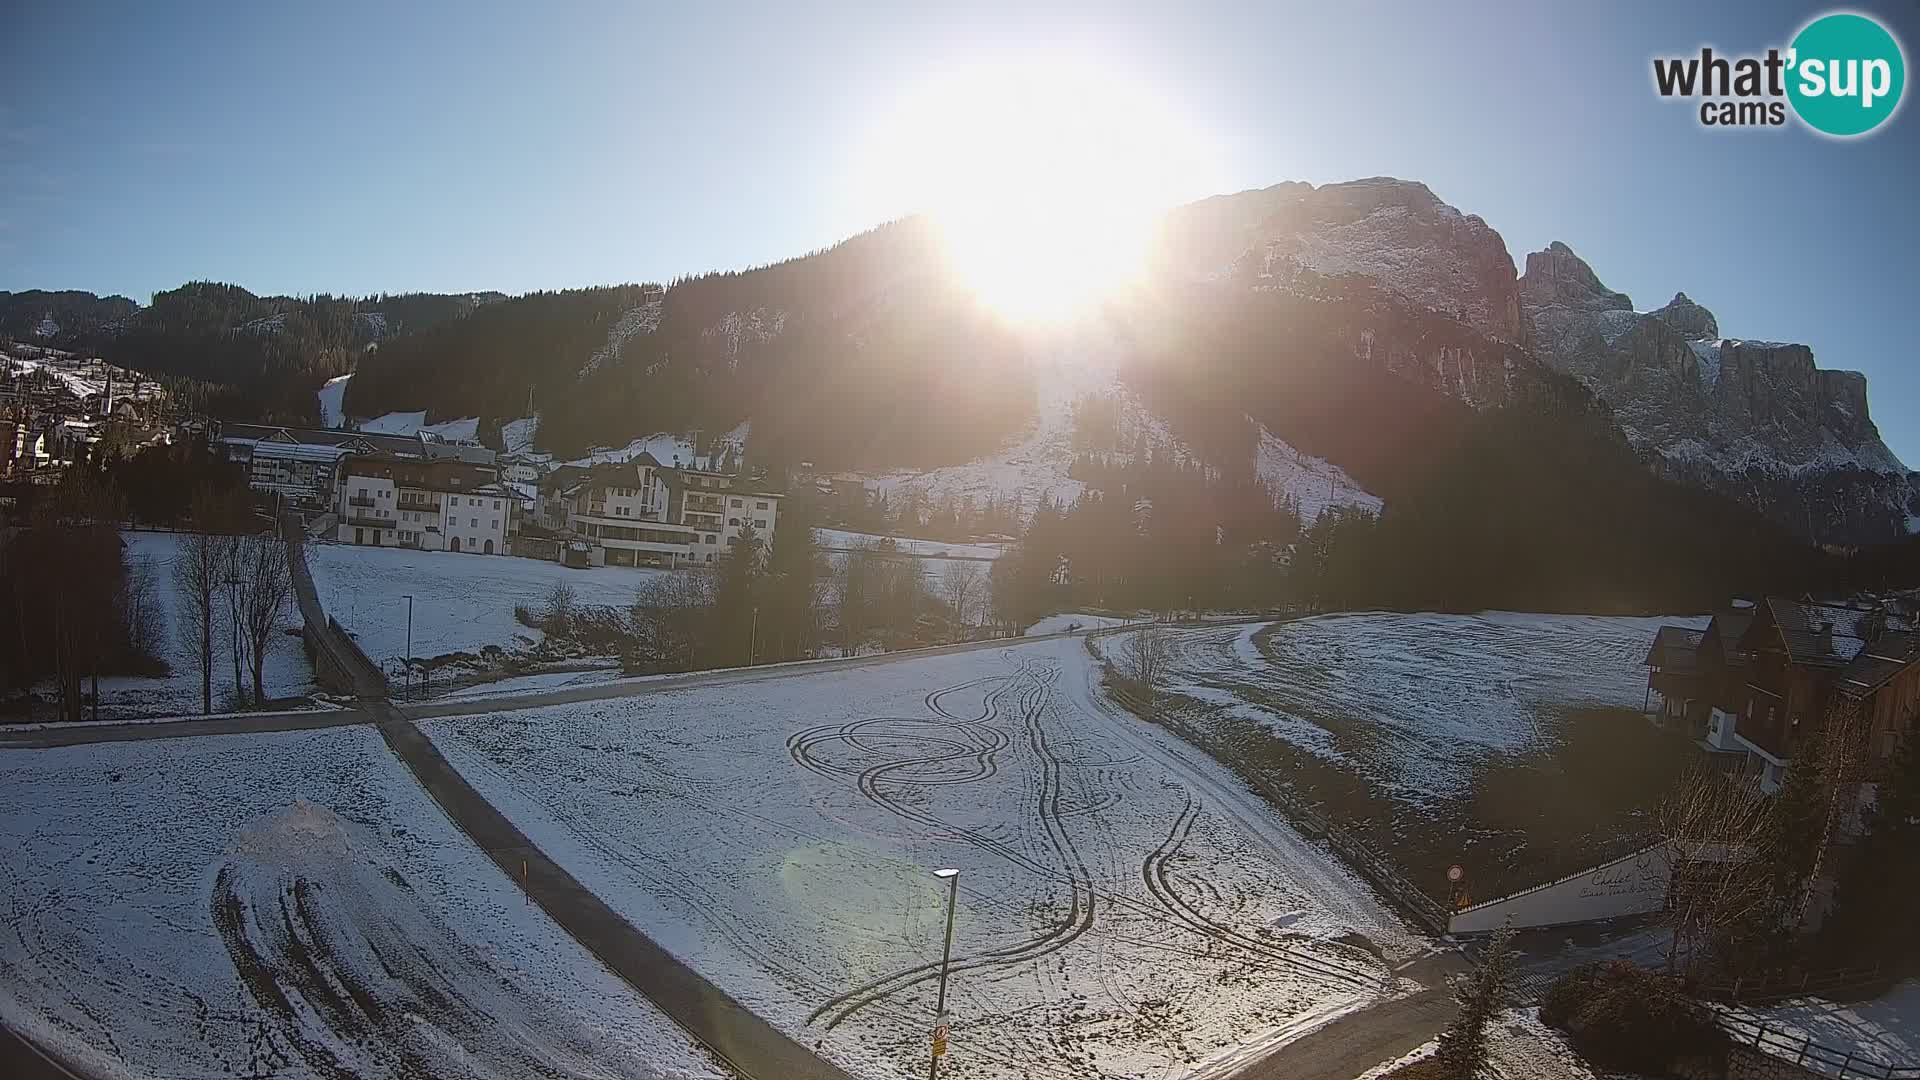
[860,63,1200,323]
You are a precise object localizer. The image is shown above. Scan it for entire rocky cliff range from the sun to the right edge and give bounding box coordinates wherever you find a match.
[1162,177,1920,542]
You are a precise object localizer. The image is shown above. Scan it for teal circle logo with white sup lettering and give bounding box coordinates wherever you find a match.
[1788,12,1907,138]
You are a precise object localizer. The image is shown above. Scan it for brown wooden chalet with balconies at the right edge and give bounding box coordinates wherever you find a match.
[1736,596,1912,792]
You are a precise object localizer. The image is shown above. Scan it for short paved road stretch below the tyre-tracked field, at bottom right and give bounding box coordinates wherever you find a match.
[1233,953,1469,1080]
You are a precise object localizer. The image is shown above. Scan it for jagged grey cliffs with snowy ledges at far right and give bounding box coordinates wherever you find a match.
[1521,242,1916,542]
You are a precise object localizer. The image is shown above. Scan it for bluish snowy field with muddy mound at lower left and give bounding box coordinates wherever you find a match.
[0,728,722,1080]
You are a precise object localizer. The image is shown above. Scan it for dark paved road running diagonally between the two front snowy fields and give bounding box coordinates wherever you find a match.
[376,705,851,1080]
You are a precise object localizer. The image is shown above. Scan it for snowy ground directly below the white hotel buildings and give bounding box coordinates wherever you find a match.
[307,544,670,667]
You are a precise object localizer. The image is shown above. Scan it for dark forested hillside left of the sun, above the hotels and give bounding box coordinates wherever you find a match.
[346,221,1033,467]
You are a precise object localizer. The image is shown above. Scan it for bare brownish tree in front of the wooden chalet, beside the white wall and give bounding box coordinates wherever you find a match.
[1657,769,1776,970]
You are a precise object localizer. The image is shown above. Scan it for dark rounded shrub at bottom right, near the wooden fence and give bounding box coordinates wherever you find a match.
[1540,961,1724,1076]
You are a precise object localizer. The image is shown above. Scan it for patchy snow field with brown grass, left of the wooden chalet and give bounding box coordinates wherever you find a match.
[1094,611,1705,899]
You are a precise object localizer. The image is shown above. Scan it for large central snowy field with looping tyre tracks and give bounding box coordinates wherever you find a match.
[422,640,1415,1080]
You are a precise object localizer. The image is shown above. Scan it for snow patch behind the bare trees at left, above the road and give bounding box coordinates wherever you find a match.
[57,532,313,721]
